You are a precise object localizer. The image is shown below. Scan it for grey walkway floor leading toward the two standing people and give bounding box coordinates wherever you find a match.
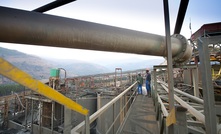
[120,95,159,134]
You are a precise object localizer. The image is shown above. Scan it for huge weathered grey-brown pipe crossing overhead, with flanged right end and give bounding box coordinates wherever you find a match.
[0,7,192,63]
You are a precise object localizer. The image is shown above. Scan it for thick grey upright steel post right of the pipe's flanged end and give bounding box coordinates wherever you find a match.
[197,38,217,134]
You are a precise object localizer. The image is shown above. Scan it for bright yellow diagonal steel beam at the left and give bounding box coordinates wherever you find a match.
[0,58,89,115]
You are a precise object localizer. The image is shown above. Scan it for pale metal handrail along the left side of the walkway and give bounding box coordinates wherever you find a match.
[71,82,137,134]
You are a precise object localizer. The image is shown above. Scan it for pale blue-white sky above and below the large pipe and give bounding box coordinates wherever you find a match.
[0,0,221,62]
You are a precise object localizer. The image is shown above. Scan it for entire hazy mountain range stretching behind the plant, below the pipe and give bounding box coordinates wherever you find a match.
[0,47,164,83]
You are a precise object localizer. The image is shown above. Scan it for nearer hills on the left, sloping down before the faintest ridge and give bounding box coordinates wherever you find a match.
[0,47,109,81]
